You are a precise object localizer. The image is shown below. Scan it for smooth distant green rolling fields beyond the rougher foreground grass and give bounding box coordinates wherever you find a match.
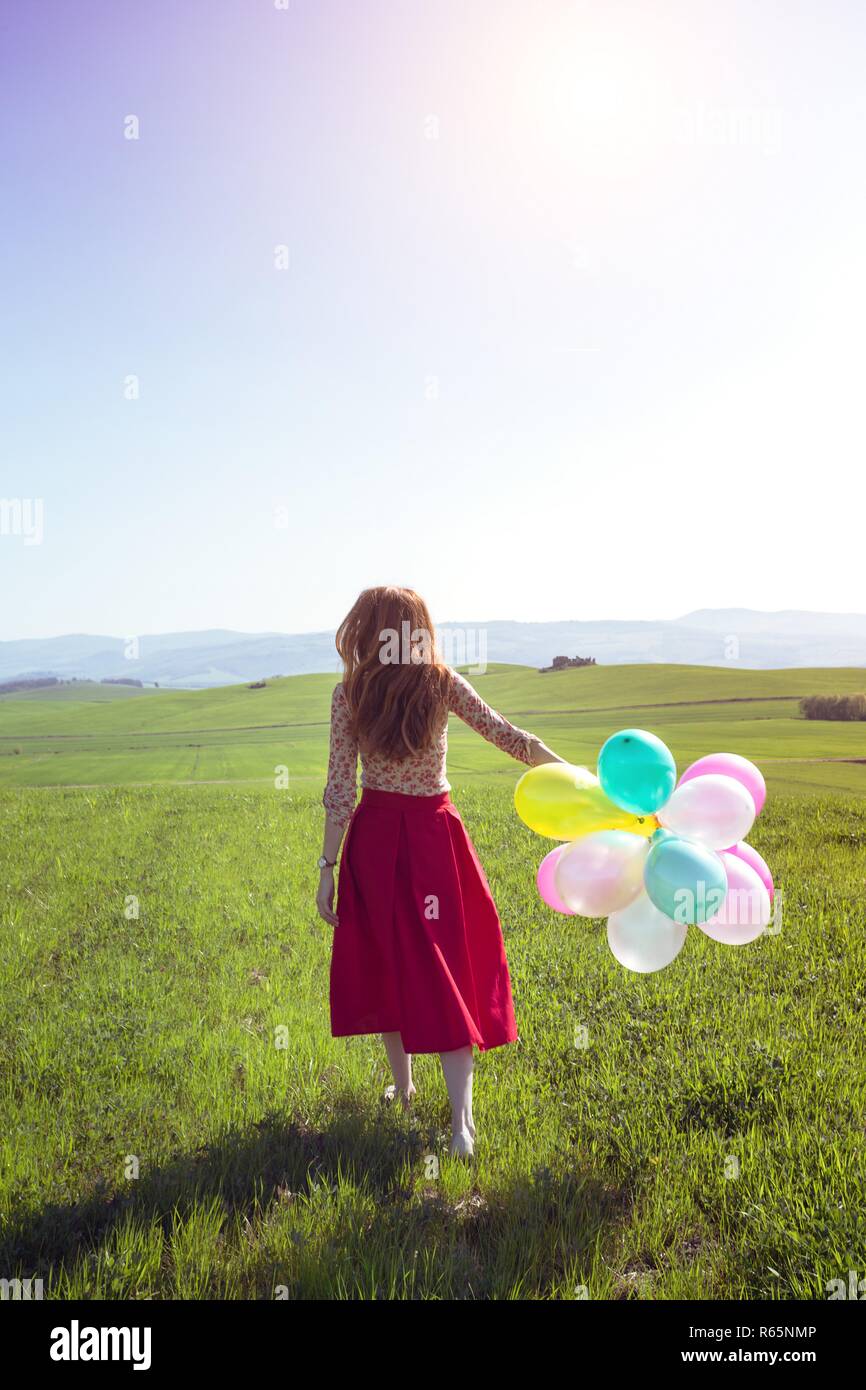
[0,666,866,795]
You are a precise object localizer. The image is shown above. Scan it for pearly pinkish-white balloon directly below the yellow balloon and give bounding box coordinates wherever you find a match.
[555,830,649,917]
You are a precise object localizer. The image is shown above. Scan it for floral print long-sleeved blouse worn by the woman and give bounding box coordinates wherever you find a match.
[322,667,538,827]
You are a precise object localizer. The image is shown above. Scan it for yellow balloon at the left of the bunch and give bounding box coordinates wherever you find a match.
[514,763,659,840]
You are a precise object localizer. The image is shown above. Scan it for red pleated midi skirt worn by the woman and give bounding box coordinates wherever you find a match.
[331,788,517,1052]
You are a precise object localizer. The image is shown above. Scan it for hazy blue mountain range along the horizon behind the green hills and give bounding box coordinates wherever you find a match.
[0,609,866,689]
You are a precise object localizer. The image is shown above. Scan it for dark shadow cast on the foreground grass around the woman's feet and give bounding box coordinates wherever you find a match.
[0,1097,630,1298]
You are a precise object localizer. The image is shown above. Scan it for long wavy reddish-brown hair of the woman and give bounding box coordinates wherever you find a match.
[336,585,450,759]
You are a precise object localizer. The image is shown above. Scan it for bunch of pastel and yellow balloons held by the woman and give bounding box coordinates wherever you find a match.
[514,728,774,974]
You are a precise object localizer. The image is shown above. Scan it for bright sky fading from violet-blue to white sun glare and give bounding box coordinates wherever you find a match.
[0,0,866,639]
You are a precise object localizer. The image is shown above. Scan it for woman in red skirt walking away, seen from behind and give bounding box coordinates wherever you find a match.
[317,588,562,1156]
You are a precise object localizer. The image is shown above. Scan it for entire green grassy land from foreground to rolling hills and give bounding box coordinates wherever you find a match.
[0,667,866,1300]
